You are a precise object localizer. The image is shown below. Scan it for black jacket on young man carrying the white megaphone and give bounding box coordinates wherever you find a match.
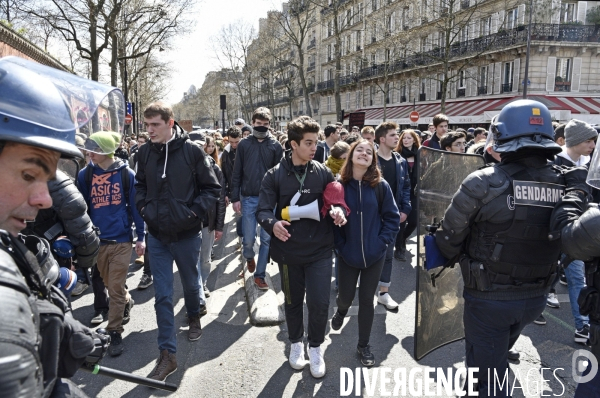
[256,151,334,264]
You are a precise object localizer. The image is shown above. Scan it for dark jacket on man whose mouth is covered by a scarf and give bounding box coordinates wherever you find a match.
[230,134,283,202]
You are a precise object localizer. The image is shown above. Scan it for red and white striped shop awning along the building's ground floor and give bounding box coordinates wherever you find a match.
[346,95,600,125]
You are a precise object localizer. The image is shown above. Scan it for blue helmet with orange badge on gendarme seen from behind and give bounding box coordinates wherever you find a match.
[490,99,562,154]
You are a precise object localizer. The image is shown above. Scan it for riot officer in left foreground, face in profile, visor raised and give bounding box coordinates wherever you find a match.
[0,57,114,398]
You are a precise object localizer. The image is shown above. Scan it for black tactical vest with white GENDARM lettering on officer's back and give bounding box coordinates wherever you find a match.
[466,163,565,291]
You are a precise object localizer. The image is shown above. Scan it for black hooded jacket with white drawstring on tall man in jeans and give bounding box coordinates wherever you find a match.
[135,127,221,243]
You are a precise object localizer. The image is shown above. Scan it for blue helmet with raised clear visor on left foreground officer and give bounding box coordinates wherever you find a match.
[0,57,125,158]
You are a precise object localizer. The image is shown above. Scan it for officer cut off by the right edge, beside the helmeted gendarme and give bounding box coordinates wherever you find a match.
[551,150,600,398]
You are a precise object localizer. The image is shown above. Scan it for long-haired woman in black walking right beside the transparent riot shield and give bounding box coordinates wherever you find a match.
[395,129,421,261]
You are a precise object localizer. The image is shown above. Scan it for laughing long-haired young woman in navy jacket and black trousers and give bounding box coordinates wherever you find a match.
[331,139,400,366]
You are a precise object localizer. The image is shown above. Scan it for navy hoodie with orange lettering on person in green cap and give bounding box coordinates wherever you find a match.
[77,159,144,243]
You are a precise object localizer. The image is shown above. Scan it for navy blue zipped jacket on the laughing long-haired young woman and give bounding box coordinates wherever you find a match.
[333,179,400,268]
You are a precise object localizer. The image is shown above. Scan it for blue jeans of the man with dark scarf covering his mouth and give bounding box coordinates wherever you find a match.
[241,196,271,278]
